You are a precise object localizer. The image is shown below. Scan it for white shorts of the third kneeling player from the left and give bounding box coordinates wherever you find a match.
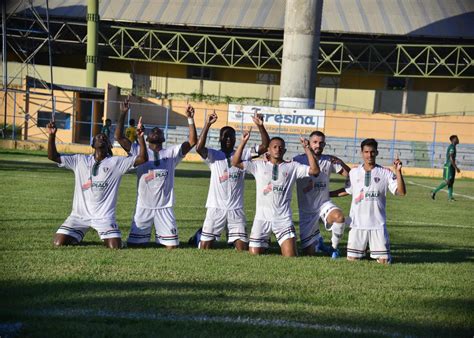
[201,208,249,243]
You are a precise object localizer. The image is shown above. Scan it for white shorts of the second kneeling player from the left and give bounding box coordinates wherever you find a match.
[127,206,179,246]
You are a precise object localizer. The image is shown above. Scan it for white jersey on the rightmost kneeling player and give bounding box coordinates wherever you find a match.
[346,164,397,230]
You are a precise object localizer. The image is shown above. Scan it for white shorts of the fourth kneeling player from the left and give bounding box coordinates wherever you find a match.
[249,219,296,248]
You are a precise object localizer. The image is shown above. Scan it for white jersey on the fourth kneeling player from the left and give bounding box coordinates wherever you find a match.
[243,161,309,221]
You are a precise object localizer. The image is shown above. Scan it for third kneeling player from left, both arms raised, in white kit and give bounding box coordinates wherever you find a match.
[196,113,269,251]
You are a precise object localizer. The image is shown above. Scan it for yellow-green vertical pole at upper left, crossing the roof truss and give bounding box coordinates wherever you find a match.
[86,0,99,88]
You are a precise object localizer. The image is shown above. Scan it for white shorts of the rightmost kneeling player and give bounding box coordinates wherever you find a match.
[347,228,390,259]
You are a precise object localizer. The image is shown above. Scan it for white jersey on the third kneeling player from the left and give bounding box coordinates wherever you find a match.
[205,148,252,210]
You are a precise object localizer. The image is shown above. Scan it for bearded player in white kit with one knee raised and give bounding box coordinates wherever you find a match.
[293,131,350,259]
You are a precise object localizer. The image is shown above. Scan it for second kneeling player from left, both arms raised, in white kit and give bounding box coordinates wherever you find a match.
[115,99,197,249]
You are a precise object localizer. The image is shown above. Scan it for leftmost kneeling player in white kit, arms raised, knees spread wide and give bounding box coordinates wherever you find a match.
[47,121,147,249]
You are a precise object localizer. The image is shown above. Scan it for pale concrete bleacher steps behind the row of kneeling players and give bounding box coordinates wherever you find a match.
[161,127,474,170]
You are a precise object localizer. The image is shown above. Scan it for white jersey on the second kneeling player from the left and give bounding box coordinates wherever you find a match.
[130,143,184,209]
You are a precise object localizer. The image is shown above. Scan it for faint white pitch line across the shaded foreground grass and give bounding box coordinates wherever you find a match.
[26,309,406,337]
